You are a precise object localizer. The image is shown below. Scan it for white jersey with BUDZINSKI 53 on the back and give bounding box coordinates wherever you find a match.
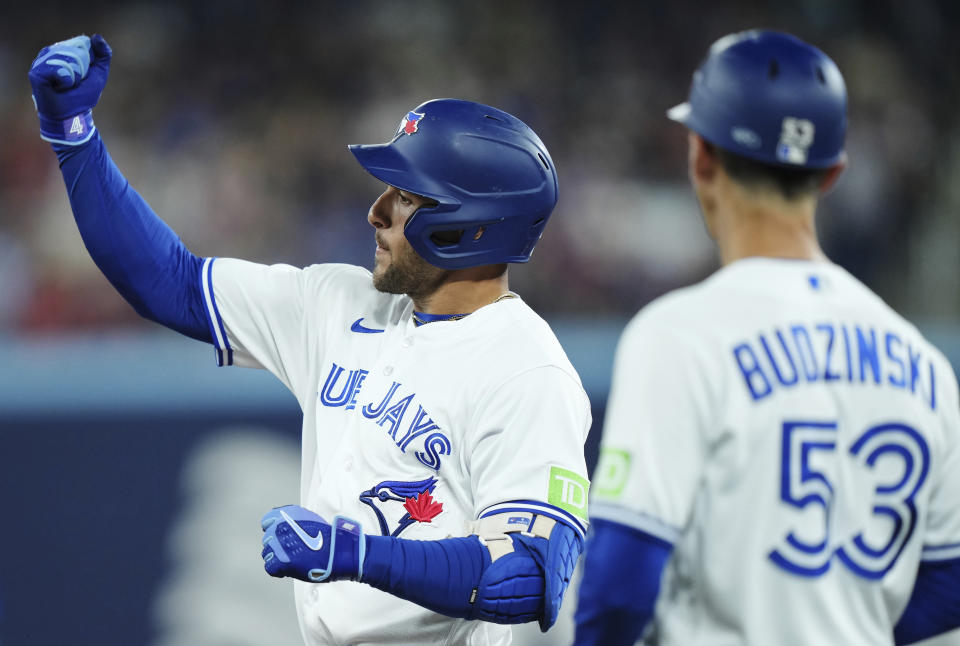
[591,258,960,646]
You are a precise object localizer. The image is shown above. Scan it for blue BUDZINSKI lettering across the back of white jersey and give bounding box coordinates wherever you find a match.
[731,321,937,410]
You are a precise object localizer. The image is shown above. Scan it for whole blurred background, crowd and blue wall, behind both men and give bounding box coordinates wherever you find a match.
[0,0,960,646]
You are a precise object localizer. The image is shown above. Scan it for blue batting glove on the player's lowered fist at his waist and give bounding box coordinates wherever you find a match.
[260,505,366,583]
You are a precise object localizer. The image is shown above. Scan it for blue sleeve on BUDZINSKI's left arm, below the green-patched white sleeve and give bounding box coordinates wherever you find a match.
[574,518,673,646]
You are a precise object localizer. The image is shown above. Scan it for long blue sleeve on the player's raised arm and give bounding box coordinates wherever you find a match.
[53,132,213,342]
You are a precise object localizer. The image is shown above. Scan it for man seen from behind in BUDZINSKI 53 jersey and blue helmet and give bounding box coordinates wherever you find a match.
[576,31,960,646]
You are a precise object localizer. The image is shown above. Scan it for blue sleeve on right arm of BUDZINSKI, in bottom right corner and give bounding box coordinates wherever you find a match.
[893,559,960,645]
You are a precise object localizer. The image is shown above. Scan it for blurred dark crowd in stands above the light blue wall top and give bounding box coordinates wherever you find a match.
[0,0,960,334]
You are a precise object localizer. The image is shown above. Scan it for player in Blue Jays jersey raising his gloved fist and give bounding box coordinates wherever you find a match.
[30,36,590,645]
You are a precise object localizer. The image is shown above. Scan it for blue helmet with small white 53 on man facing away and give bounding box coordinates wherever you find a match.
[667,30,847,169]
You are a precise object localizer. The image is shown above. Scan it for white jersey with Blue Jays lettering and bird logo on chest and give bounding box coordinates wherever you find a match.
[203,259,590,646]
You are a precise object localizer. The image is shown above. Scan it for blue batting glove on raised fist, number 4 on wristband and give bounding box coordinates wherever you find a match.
[29,34,113,146]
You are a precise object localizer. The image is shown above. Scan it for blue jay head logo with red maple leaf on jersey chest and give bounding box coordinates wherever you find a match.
[360,478,443,536]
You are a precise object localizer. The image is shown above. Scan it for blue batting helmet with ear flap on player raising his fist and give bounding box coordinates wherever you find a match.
[350,99,557,269]
